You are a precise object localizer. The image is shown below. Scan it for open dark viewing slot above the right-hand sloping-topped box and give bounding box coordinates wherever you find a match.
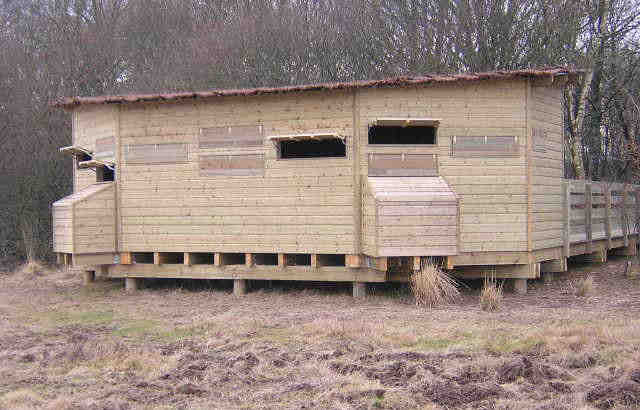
[369,118,439,145]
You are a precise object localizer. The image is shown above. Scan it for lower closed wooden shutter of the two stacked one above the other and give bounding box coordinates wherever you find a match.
[199,154,264,176]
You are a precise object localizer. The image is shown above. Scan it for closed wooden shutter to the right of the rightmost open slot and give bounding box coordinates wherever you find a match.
[451,135,520,158]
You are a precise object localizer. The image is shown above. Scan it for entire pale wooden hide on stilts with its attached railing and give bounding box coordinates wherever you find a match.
[53,68,640,294]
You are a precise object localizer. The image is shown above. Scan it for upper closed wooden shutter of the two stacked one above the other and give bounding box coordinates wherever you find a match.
[198,125,263,149]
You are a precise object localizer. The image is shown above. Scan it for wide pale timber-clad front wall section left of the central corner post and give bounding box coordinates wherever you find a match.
[118,91,357,254]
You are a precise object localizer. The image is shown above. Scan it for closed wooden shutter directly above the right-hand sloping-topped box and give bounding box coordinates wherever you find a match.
[369,153,438,177]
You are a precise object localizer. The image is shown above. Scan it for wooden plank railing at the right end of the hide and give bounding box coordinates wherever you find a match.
[563,180,640,255]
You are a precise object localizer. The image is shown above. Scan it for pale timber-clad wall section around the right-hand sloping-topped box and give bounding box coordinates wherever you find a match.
[358,81,527,252]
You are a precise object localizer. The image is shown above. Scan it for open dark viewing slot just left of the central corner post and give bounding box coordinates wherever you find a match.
[270,134,347,159]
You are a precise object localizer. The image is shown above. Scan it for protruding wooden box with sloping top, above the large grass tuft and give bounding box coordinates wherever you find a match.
[363,177,458,257]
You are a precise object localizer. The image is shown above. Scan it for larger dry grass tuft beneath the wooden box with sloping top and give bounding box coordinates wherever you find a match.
[409,260,460,308]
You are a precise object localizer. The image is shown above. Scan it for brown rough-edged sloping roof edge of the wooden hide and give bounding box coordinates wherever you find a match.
[53,67,582,109]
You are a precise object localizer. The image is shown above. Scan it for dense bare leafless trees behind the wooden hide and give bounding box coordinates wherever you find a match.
[0,0,640,259]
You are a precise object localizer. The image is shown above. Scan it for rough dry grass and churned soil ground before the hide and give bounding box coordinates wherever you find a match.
[0,259,640,409]
